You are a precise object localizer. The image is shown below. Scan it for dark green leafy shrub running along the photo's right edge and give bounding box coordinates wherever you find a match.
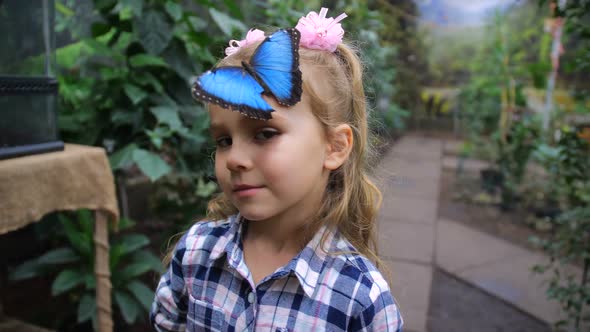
[532,127,590,331]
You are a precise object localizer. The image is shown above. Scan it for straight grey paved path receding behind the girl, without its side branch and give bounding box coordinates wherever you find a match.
[375,136,442,331]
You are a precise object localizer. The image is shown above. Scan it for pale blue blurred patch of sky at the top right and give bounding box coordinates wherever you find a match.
[414,0,521,26]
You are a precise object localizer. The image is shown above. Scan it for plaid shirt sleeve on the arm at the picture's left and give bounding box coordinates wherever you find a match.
[150,234,188,331]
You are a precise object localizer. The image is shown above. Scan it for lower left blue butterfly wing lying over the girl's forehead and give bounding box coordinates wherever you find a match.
[191,67,273,120]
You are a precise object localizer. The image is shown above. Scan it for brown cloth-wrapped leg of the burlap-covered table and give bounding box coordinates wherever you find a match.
[94,210,113,332]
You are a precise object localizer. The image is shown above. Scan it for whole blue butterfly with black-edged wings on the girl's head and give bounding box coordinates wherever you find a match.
[191,28,302,120]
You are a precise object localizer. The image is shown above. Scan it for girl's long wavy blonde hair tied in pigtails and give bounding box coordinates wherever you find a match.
[202,39,383,268]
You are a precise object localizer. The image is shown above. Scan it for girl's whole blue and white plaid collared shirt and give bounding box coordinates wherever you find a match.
[150,216,402,332]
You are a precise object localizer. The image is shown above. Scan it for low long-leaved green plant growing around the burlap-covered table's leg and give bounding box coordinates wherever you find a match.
[9,210,162,329]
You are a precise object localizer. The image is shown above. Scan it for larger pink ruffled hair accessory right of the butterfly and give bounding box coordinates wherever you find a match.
[295,7,347,52]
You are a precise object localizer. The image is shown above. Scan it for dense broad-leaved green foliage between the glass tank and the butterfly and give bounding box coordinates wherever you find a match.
[58,0,227,181]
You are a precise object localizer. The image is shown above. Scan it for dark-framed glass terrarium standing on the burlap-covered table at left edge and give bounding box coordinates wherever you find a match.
[0,0,64,159]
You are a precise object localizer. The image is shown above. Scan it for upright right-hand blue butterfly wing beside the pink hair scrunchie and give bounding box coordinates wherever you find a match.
[250,28,302,106]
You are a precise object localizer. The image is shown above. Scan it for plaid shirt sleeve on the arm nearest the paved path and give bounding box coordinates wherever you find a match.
[350,287,403,332]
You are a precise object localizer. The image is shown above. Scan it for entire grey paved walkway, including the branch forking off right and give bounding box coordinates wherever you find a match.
[375,136,580,332]
